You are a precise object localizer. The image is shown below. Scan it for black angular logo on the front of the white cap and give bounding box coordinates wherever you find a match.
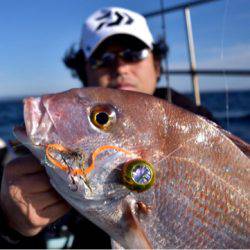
[95,10,134,31]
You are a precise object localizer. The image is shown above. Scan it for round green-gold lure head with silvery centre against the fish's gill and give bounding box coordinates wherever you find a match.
[122,159,155,192]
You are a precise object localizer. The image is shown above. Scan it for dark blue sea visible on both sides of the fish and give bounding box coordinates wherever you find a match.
[0,90,250,143]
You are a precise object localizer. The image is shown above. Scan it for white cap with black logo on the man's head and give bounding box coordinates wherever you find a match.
[80,7,154,58]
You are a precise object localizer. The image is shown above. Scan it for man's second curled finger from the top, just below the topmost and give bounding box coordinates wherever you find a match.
[15,172,52,195]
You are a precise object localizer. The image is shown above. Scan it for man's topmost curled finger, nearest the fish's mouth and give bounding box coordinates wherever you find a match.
[6,155,44,175]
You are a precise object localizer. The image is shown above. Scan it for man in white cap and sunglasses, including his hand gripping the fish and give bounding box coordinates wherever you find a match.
[1,5,213,248]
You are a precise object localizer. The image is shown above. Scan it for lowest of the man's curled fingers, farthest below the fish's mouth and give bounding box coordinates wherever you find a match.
[38,201,71,224]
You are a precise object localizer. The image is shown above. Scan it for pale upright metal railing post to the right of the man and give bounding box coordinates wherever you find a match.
[184,7,201,106]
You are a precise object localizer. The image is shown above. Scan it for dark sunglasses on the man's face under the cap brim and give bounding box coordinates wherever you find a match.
[89,48,149,69]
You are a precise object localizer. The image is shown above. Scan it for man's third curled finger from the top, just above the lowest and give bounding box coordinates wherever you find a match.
[24,189,63,210]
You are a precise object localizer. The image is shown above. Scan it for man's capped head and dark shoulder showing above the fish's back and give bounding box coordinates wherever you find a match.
[64,8,213,120]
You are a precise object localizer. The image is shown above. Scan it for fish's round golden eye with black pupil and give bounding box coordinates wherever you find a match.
[90,105,116,131]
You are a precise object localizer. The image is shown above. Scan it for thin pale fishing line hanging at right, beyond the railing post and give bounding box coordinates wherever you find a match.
[220,0,229,130]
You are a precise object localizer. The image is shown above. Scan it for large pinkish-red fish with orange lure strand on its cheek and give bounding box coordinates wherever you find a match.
[14,87,250,249]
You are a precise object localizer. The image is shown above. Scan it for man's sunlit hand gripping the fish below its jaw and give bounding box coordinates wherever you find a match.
[0,156,70,236]
